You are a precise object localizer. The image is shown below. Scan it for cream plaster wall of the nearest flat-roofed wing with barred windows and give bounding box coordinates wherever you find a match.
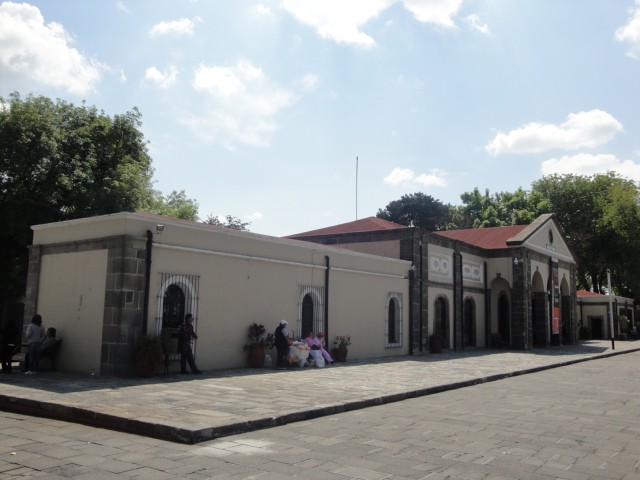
[34,214,410,372]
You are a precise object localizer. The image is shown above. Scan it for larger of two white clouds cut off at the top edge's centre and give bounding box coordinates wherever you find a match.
[282,0,395,47]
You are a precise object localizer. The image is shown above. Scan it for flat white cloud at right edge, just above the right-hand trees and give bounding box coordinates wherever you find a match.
[542,153,640,182]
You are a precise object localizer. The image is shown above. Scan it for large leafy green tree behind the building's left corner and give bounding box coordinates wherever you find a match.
[0,93,152,302]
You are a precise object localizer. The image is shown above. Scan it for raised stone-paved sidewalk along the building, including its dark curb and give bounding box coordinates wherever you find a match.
[0,340,640,443]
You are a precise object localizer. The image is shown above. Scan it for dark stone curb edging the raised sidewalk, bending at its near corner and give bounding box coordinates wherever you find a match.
[0,348,640,444]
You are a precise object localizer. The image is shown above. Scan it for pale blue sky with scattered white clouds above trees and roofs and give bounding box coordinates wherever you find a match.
[0,0,640,236]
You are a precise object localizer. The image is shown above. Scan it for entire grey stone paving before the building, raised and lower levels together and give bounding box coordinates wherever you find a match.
[0,342,640,480]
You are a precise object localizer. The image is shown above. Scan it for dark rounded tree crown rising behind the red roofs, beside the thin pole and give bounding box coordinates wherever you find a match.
[376,192,451,232]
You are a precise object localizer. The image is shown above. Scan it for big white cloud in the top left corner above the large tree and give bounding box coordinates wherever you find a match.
[0,2,104,95]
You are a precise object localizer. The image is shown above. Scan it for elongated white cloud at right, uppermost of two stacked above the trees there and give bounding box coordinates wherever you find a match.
[484,110,623,155]
